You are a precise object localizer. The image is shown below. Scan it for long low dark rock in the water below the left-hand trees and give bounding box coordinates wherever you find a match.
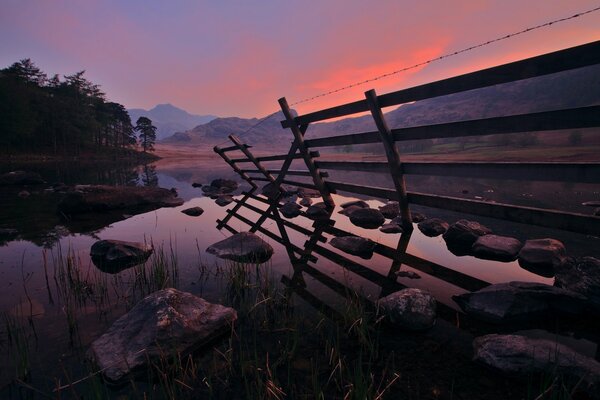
[58,185,183,214]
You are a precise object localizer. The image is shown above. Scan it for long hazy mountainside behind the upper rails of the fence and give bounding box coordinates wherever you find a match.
[165,66,600,149]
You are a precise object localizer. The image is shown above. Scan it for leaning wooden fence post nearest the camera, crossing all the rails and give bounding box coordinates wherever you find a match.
[365,89,413,230]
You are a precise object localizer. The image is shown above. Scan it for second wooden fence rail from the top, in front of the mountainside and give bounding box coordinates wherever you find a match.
[305,106,600,148]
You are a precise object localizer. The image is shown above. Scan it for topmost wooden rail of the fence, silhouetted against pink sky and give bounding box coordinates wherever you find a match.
[281,41,600,128]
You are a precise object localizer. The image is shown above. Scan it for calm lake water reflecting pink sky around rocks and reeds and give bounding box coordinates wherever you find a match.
[0,160,600,396]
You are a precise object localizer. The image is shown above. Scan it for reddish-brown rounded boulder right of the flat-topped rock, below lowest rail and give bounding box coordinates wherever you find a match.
[519,238,567,269]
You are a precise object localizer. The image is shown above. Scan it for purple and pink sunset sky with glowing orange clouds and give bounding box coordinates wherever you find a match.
[0,0,600,118]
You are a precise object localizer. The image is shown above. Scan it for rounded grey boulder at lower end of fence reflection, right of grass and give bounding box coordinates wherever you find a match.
[379,288,436,331]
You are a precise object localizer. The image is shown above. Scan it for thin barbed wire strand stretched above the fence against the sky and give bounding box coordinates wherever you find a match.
[217,6,600,146]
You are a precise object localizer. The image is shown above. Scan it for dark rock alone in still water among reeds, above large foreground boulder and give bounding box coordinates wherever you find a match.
[90,240,154,274]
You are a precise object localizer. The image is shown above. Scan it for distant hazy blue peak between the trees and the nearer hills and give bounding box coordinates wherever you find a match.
[127,104,217,140]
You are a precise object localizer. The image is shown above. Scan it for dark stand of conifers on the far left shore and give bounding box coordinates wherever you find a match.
[0,59,156,156]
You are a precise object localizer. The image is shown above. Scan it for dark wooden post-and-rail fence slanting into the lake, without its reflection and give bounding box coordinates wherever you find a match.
[215,41,600,234]
